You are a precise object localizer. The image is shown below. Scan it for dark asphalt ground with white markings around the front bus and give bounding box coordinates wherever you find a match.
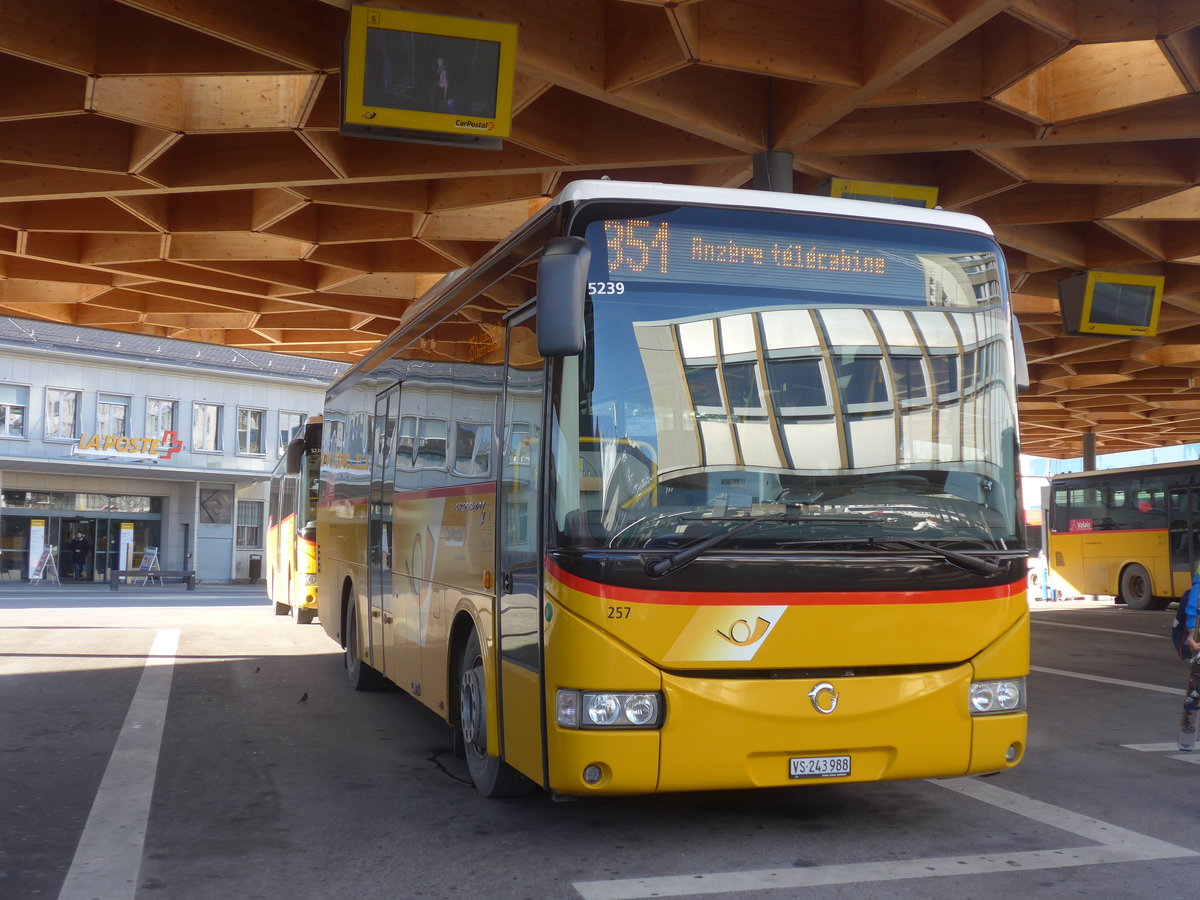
[0,583,1200,900]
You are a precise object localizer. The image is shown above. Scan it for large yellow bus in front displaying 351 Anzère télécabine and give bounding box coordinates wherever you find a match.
[317,180,1028,797]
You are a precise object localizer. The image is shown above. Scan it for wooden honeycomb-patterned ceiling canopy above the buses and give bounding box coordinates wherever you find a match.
[0,0,1200,457]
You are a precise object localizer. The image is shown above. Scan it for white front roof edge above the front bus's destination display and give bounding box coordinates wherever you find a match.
[554,179,992,236]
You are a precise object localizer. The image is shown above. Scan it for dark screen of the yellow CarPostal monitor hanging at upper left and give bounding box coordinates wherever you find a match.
[362,28,500,119]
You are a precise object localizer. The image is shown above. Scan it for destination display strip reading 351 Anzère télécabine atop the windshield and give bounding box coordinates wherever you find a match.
[587,209,1001,306]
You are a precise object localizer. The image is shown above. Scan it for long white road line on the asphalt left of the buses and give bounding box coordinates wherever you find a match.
[59,629,179,900]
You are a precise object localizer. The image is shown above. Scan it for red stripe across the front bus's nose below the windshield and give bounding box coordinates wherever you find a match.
[546,559,1025,606]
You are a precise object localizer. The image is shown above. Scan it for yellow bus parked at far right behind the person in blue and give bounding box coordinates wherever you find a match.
[1046,462,1200,610]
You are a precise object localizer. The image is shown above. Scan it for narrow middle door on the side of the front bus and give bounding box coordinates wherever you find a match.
[365,384,400,677]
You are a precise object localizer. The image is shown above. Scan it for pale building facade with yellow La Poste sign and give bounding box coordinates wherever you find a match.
[0,318,344,583]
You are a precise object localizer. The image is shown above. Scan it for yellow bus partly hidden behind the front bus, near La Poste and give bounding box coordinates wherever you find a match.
[266,416,322,625]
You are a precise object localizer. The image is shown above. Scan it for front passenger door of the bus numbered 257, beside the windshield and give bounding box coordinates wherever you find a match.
[497,313,546,784]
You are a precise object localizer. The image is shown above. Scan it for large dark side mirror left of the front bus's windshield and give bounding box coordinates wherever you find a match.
[538,238,592,358]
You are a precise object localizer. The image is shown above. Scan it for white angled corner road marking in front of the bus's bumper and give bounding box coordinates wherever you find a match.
[575,779,1200,900]
